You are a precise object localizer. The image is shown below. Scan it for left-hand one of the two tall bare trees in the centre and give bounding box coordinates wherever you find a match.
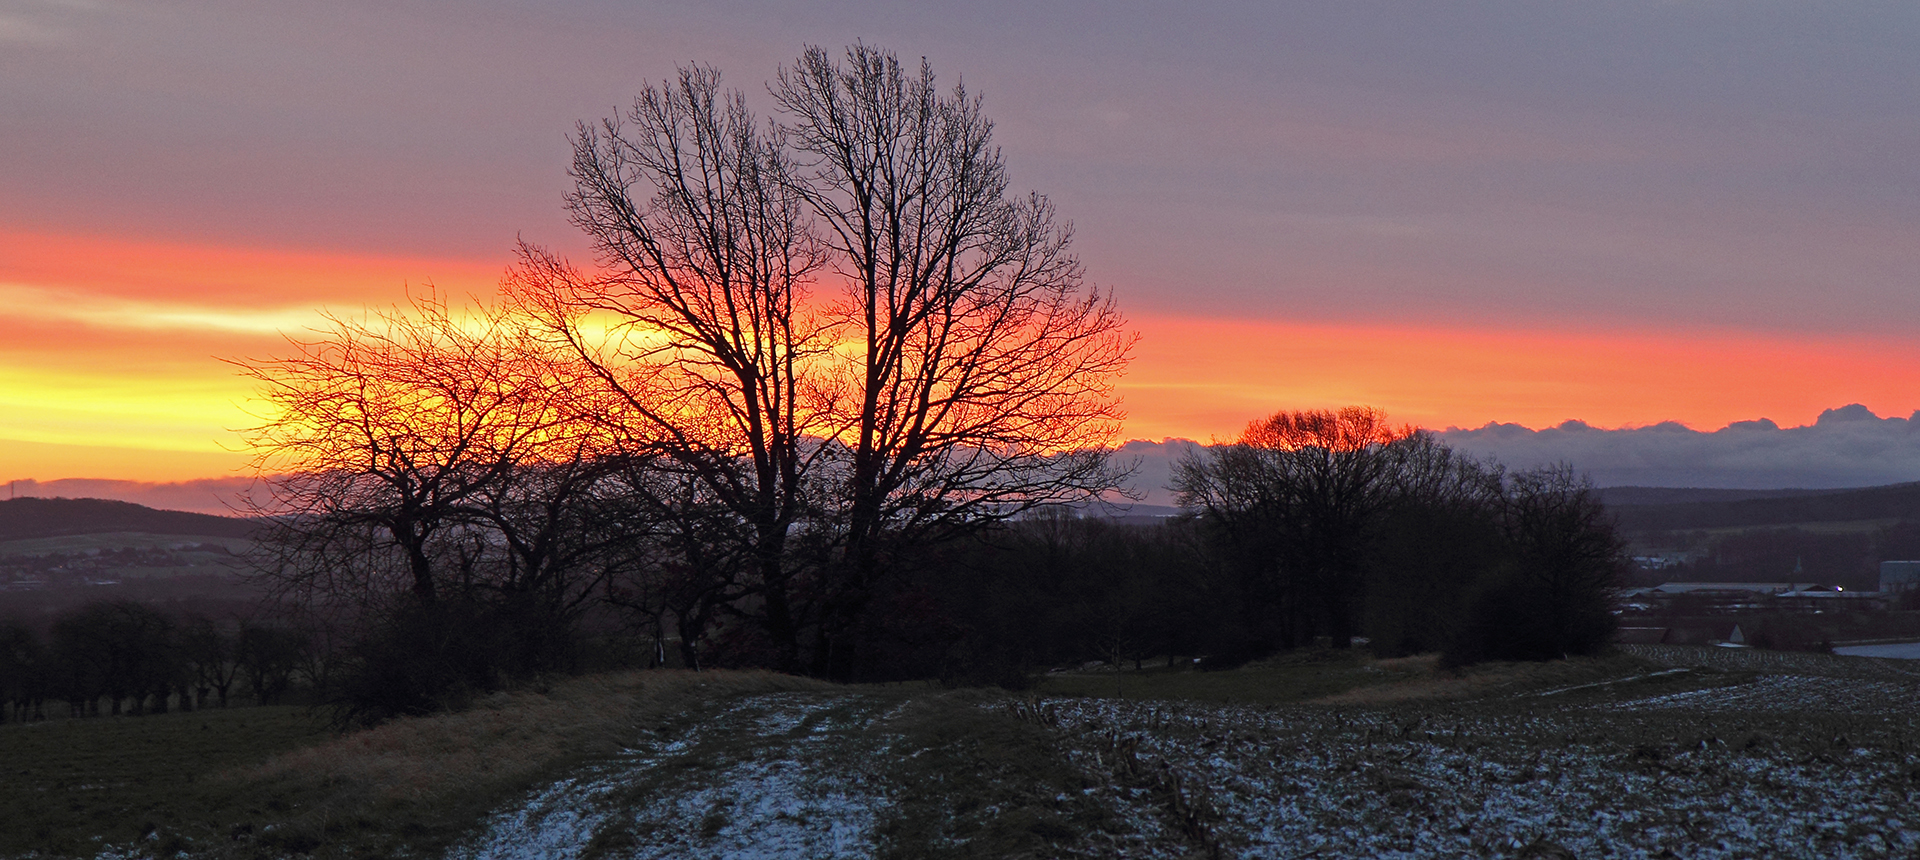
[509,67,831,666]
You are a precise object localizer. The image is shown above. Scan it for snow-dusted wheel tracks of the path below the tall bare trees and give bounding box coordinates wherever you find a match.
[447,693,887,860]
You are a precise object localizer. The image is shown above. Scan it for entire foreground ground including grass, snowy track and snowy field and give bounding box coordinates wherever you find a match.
[0,647,1920,860]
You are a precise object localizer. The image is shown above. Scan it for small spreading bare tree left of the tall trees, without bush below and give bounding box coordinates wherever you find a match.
[236,294,591,605]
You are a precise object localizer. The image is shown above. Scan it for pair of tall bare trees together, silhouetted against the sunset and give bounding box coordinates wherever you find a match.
[511,46,1133,676]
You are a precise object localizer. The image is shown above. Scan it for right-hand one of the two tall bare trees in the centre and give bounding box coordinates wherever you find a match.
[774,44,1133,674]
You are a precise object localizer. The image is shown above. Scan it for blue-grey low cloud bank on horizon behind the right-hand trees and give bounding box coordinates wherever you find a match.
[1119,403,1920,505]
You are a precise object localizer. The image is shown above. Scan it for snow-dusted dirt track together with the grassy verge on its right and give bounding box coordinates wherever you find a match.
[447,689,1194,860]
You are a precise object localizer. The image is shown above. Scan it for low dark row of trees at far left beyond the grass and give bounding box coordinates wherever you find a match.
[0,601,309,722]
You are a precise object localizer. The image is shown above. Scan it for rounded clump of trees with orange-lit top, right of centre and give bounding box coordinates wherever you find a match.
[1175,407,1624,658]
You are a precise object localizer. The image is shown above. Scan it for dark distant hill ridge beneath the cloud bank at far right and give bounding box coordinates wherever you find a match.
[1601,482,1920,532]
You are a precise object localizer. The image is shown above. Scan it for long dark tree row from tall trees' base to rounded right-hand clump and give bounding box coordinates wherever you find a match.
[874,409,1626,685]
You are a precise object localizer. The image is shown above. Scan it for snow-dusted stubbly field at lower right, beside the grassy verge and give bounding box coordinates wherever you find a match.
[1044,678,1920,858]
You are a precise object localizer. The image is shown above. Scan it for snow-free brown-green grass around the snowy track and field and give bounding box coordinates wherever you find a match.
[11,651,1908,858]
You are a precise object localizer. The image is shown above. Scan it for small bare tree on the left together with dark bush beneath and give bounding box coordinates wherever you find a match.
[240,296,626,720]
